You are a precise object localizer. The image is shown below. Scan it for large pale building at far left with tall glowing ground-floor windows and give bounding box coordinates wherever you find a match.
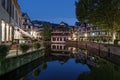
[0,0,22,44]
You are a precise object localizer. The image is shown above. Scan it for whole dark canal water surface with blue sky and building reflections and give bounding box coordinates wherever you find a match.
[0,44,120,80]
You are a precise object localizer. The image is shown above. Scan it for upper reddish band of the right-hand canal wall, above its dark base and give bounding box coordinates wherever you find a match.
[66,41,120,56]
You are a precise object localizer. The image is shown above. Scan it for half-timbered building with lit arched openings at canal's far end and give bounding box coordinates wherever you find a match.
[51,22,70,43]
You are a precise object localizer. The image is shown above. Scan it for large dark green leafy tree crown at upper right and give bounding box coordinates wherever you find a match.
[76,0,120,41]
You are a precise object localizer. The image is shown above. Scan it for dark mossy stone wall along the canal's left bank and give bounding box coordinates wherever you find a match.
[0,50,44,75]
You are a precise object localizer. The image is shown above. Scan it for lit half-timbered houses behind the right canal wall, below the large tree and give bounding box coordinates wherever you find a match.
[75,22,112,41]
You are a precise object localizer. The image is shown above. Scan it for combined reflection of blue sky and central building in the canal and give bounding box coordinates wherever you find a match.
[21,44,90,80]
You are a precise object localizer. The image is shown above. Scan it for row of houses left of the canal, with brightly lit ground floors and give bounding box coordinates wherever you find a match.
[0,0,50,45]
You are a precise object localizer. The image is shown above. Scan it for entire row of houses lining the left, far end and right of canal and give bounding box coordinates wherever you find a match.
[0,0,115,44]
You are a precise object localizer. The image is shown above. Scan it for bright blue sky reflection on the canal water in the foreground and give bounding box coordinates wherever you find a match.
[24,59,90,80]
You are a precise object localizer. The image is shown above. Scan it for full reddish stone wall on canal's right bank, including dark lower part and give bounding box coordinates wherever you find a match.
[66,41,120,65]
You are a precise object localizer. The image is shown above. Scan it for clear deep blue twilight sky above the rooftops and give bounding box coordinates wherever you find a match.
[18,0,77,25]
